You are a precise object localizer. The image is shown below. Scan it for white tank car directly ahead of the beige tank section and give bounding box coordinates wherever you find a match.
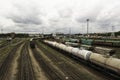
[77,49,92,60]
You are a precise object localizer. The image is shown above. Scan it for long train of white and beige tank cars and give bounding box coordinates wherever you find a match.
[44,40,120,80]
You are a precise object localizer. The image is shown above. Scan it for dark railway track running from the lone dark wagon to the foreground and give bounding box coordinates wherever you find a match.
[32,50,64,80]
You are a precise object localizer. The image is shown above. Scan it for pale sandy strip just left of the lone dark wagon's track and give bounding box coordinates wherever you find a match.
[29,48,48,80]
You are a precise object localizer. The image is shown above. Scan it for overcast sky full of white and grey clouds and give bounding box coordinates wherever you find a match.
[0,0,120,33]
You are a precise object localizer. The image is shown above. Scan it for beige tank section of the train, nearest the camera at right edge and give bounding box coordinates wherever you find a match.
[90,53,120,73]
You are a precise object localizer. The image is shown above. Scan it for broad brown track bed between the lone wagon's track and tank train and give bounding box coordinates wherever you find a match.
[33,43,102,80]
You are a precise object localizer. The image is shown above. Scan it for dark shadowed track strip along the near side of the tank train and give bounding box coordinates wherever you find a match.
[37,41,120,80]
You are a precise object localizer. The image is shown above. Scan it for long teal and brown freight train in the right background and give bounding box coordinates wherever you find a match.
[64,38,120,47]
